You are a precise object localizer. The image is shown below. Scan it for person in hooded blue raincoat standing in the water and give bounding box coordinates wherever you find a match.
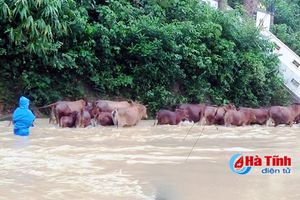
[12,96,35,136]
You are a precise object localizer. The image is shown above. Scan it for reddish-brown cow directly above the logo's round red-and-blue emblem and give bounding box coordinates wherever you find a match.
[224,109,255,126]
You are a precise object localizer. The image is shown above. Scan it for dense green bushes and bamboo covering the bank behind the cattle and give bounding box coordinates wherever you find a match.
[0,0,286,115]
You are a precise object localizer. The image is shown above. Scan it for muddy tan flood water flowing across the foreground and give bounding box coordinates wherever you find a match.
[0,119,300,200]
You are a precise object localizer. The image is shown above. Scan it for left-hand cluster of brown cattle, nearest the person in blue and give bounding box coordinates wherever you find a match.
[39,99,148,128]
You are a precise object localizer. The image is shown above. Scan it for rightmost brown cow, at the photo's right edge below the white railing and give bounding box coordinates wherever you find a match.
[269,104,300,126]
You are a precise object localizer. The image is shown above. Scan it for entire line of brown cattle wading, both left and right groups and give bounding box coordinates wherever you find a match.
[40,100,300,128]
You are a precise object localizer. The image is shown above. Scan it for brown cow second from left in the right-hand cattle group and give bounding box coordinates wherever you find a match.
[178,104,205,122]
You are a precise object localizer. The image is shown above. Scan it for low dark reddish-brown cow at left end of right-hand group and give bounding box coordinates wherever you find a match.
[156,109,189,125]
